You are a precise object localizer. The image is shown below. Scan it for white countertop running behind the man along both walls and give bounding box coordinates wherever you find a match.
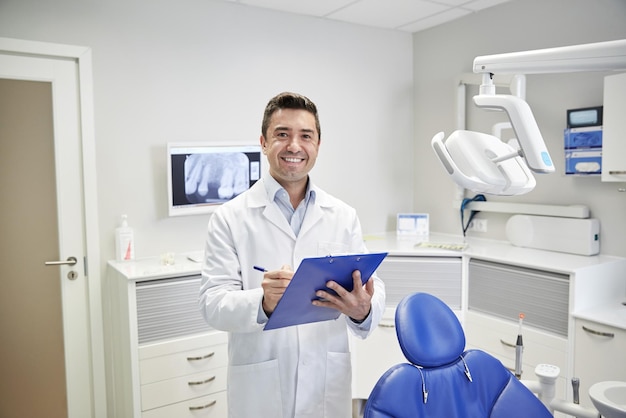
[109,232,626,329]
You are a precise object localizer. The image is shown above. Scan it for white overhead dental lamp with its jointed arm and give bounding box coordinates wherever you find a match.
[431,39,626,196]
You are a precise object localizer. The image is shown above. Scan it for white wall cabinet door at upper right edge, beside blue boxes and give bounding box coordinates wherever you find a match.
[602,73,626,182]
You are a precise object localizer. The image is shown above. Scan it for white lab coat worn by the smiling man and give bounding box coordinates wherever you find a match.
[200,179,385,418]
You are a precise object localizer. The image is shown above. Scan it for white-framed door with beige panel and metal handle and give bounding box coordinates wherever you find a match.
[0,40,104,418]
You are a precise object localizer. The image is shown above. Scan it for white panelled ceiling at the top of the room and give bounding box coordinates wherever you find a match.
[225,0,509,33]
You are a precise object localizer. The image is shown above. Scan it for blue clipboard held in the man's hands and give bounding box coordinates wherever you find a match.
[263,253,387,330]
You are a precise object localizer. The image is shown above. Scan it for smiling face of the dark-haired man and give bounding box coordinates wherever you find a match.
[261,109,320,189]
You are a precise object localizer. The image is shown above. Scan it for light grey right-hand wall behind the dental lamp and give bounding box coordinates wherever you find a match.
[413,0,626,256]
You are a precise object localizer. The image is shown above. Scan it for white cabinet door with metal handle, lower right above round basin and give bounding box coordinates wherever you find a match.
[574,319,626,407]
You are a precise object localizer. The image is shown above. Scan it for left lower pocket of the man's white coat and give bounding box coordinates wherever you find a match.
[228,360,283,418]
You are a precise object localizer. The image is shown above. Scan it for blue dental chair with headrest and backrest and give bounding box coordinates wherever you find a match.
[364,293,552,418]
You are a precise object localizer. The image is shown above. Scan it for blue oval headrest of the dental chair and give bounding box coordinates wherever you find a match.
[395,293,465,367]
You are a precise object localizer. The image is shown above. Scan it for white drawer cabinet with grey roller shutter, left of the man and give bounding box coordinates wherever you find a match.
[105,257,228,418]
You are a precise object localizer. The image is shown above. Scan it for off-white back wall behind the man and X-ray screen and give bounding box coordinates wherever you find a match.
[0,0,414,260]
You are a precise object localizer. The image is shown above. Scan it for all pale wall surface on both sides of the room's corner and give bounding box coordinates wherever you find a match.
[0,0,626,260]
